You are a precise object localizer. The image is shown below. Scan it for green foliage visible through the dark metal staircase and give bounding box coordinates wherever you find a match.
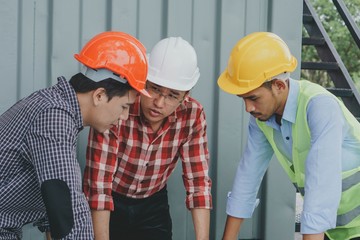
[301,0,360,89]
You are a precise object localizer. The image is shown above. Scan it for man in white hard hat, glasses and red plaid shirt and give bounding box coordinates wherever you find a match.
[84,37,212,240]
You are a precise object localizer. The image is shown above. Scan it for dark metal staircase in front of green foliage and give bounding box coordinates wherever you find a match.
[301,0,360,121]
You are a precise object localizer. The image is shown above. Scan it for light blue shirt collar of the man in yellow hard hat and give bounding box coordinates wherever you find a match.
[266,78,300,130]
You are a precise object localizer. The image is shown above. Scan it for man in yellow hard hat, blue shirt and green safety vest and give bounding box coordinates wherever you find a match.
[218,32,360,240]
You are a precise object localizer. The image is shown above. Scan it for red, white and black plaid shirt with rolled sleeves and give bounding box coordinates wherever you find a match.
[84,94,212,210]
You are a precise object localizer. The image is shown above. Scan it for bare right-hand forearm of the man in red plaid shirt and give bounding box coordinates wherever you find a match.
[191,208,210,240]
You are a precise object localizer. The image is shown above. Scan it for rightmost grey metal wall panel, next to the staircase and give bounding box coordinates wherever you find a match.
[262,0,302,239]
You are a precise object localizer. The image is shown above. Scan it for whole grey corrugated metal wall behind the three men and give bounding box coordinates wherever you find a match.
[0,0,302,240]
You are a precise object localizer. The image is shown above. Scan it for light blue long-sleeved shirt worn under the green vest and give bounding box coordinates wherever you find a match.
[227,79,360,234]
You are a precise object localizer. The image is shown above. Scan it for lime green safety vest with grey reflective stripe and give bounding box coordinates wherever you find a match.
[257,80,360,240]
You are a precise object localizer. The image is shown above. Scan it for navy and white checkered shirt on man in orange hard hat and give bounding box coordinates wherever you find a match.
[0,78,93,240]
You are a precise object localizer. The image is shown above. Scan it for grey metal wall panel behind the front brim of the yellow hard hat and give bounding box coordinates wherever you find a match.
[215,0,268,239]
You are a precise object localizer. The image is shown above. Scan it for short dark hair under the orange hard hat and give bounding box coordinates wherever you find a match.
[69,73,133,101]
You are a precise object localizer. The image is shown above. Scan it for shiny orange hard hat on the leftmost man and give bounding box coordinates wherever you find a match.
[74,31,150,96]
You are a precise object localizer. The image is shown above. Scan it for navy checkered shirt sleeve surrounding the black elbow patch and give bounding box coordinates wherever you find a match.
[27,109,93,240]
